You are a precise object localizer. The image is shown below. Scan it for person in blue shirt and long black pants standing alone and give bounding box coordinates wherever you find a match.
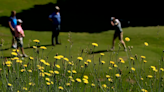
[49,6,61,46]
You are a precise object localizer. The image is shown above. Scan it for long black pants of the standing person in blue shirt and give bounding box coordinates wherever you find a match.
[52,25,60,44]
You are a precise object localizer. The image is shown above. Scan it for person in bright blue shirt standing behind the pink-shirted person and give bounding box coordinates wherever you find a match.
[8,10,17,48]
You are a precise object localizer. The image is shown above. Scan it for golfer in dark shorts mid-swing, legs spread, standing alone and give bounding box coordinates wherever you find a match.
[111,17,127,51]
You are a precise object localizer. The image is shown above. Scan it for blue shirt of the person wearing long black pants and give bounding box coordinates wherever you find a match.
[49,12,61,25]
